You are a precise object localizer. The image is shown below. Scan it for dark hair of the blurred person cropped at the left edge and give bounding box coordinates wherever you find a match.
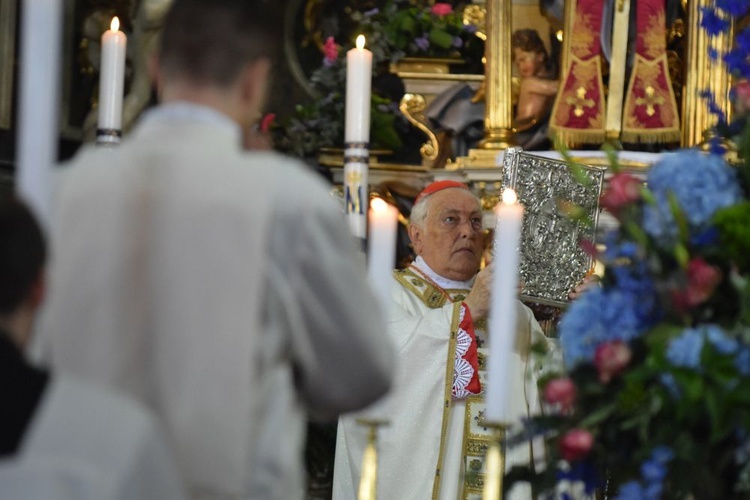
[0,198,47,314]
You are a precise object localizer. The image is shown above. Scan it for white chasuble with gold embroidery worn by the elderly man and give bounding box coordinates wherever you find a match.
[334,269,544,500]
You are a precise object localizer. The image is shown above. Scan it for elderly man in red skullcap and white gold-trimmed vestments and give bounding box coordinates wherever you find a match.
[333,181,552,500]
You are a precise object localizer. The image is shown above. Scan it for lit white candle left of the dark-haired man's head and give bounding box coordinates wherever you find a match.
[99,17,128,140]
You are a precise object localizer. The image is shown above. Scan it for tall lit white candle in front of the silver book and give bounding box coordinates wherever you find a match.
[485,189,523,423]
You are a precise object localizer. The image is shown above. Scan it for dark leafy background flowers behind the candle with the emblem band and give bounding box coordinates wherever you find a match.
[272,0,483,157]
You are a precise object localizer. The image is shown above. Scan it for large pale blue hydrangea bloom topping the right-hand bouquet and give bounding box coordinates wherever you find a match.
[643,150,742,244]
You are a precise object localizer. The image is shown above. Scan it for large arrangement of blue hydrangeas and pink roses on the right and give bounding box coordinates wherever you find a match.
[507,0,750,500]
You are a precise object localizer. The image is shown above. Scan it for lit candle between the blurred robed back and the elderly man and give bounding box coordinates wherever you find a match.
[367,198,398,307]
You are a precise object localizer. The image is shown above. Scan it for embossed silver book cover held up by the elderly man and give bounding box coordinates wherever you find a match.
[498,147,606,305]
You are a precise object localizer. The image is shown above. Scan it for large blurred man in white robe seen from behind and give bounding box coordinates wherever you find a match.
[37,0,394,500]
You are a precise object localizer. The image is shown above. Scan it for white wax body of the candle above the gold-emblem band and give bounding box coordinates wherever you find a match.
[344,42,372,143]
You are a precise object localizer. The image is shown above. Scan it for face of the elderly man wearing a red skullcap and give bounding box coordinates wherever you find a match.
[409,188,484,281]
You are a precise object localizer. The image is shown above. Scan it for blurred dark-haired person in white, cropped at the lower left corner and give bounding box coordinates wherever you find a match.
[0,198,185,500]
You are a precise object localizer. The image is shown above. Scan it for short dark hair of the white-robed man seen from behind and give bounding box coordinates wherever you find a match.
[159,0,280,86]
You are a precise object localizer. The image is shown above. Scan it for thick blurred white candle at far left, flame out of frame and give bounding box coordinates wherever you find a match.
[16,0,63,224]
